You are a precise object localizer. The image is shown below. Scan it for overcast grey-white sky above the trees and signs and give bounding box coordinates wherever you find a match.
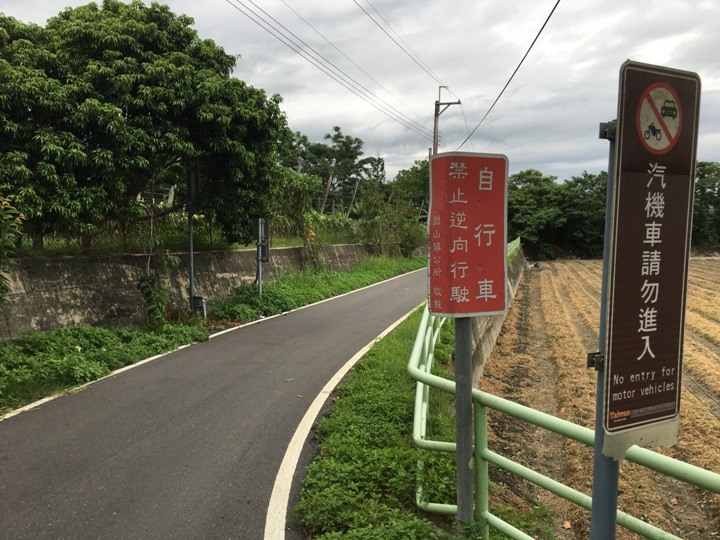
[0,0,720,180]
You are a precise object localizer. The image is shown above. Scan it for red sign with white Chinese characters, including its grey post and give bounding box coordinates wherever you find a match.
[428,152,508,523]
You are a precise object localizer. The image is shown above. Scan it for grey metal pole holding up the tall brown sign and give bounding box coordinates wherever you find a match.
[590,123,620,540]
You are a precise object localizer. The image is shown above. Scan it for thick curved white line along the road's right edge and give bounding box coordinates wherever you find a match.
[264,304,422,540]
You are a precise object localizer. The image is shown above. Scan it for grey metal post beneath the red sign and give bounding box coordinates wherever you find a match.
[455,317,474,524]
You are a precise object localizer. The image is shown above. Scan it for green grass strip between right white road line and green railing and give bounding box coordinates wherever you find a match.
[295,306,454,539]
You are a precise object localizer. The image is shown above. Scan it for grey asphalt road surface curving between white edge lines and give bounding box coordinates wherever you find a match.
[0,270,426,539]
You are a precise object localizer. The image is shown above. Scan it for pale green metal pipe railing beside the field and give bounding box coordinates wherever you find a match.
[408,304,720,540]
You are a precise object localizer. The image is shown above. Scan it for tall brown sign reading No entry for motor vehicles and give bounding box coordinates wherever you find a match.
[603,62,700,433]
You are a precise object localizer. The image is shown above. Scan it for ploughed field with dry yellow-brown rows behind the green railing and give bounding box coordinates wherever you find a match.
[477,257,720,540]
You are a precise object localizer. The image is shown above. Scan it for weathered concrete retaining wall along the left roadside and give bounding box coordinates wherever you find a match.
[0,245,369,338]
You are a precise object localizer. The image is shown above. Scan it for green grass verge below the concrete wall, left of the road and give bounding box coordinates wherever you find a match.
[0,257,426,414]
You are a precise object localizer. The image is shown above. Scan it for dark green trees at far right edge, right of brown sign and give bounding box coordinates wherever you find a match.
[692,161,720,249]
